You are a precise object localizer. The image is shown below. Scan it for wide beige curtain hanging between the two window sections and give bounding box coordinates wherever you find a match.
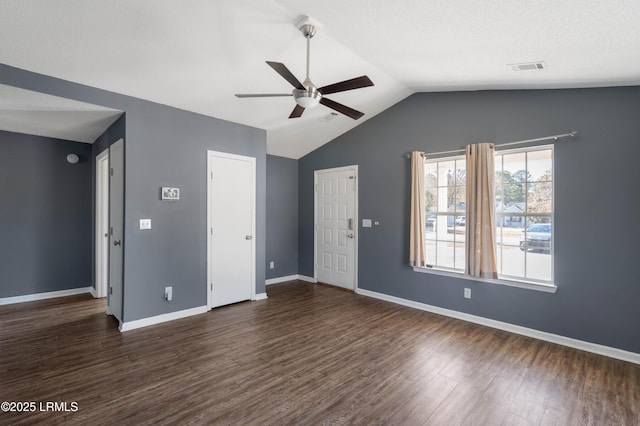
[465,143,498,278]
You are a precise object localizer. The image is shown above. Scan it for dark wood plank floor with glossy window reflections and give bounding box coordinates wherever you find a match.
[0,282,640,425]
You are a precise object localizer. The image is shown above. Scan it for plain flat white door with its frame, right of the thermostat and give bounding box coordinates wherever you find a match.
[207,151,256,308]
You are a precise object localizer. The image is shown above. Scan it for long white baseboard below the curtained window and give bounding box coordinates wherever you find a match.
[356,288,640,364]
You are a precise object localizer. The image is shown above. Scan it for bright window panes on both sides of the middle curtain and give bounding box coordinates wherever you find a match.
[425,146,553,284]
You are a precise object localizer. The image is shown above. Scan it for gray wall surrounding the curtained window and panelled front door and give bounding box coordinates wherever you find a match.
[299,87,640,352]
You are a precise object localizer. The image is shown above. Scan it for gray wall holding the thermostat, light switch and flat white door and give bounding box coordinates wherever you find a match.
[0,65,266,321]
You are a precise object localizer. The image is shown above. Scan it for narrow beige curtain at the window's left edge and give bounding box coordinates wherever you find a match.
[409,151,426,266]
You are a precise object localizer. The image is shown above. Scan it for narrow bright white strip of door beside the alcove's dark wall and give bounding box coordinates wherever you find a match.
[95,148,109,297]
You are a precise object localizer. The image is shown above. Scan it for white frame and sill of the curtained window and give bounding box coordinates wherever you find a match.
[412,145,557,293]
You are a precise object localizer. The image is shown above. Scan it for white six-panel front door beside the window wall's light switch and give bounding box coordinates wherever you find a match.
[315,166,358,290]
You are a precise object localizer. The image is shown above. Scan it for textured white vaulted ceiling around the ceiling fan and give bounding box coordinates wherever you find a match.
[0,0,640,158]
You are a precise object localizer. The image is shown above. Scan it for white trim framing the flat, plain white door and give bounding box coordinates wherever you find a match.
[205,150,256,310]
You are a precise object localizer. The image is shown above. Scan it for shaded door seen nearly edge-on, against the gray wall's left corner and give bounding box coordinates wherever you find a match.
[107,139,124,323]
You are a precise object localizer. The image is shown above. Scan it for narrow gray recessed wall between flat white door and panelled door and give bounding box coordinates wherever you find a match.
[265,155,298,279]
